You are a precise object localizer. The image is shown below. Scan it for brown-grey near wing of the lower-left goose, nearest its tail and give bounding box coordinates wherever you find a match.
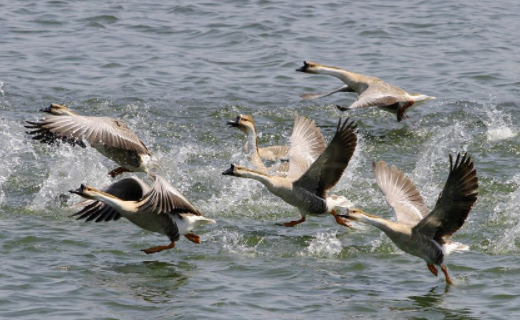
[139,176,201,216]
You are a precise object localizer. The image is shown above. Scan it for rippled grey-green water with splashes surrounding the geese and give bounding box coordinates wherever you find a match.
[0,0,520,319]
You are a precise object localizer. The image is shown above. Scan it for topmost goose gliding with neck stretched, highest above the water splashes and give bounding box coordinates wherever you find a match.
[296,61,435,122]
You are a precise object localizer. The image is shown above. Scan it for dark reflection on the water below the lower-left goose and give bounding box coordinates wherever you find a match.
[93,261,196,304]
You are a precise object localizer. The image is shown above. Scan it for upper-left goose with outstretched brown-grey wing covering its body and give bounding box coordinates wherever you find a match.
[25,103,152,177]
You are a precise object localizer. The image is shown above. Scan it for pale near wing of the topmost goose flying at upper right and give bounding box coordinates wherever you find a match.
[349,80,407,109]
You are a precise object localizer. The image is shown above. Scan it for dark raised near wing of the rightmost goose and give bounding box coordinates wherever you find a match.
[412,153,478,244]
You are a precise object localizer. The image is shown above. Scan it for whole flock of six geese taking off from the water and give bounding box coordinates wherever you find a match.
[25,61,478,284]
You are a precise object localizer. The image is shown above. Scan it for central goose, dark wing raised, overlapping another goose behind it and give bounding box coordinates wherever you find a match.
[222,118,357,228]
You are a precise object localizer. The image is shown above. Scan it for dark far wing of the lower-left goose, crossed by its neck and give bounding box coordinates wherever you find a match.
[71,177,150,222]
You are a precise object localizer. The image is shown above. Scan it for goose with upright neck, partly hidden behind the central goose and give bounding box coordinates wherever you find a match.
[228,115,326,172]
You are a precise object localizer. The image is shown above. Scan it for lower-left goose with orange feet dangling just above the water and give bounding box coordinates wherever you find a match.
[69,175,215,254]
